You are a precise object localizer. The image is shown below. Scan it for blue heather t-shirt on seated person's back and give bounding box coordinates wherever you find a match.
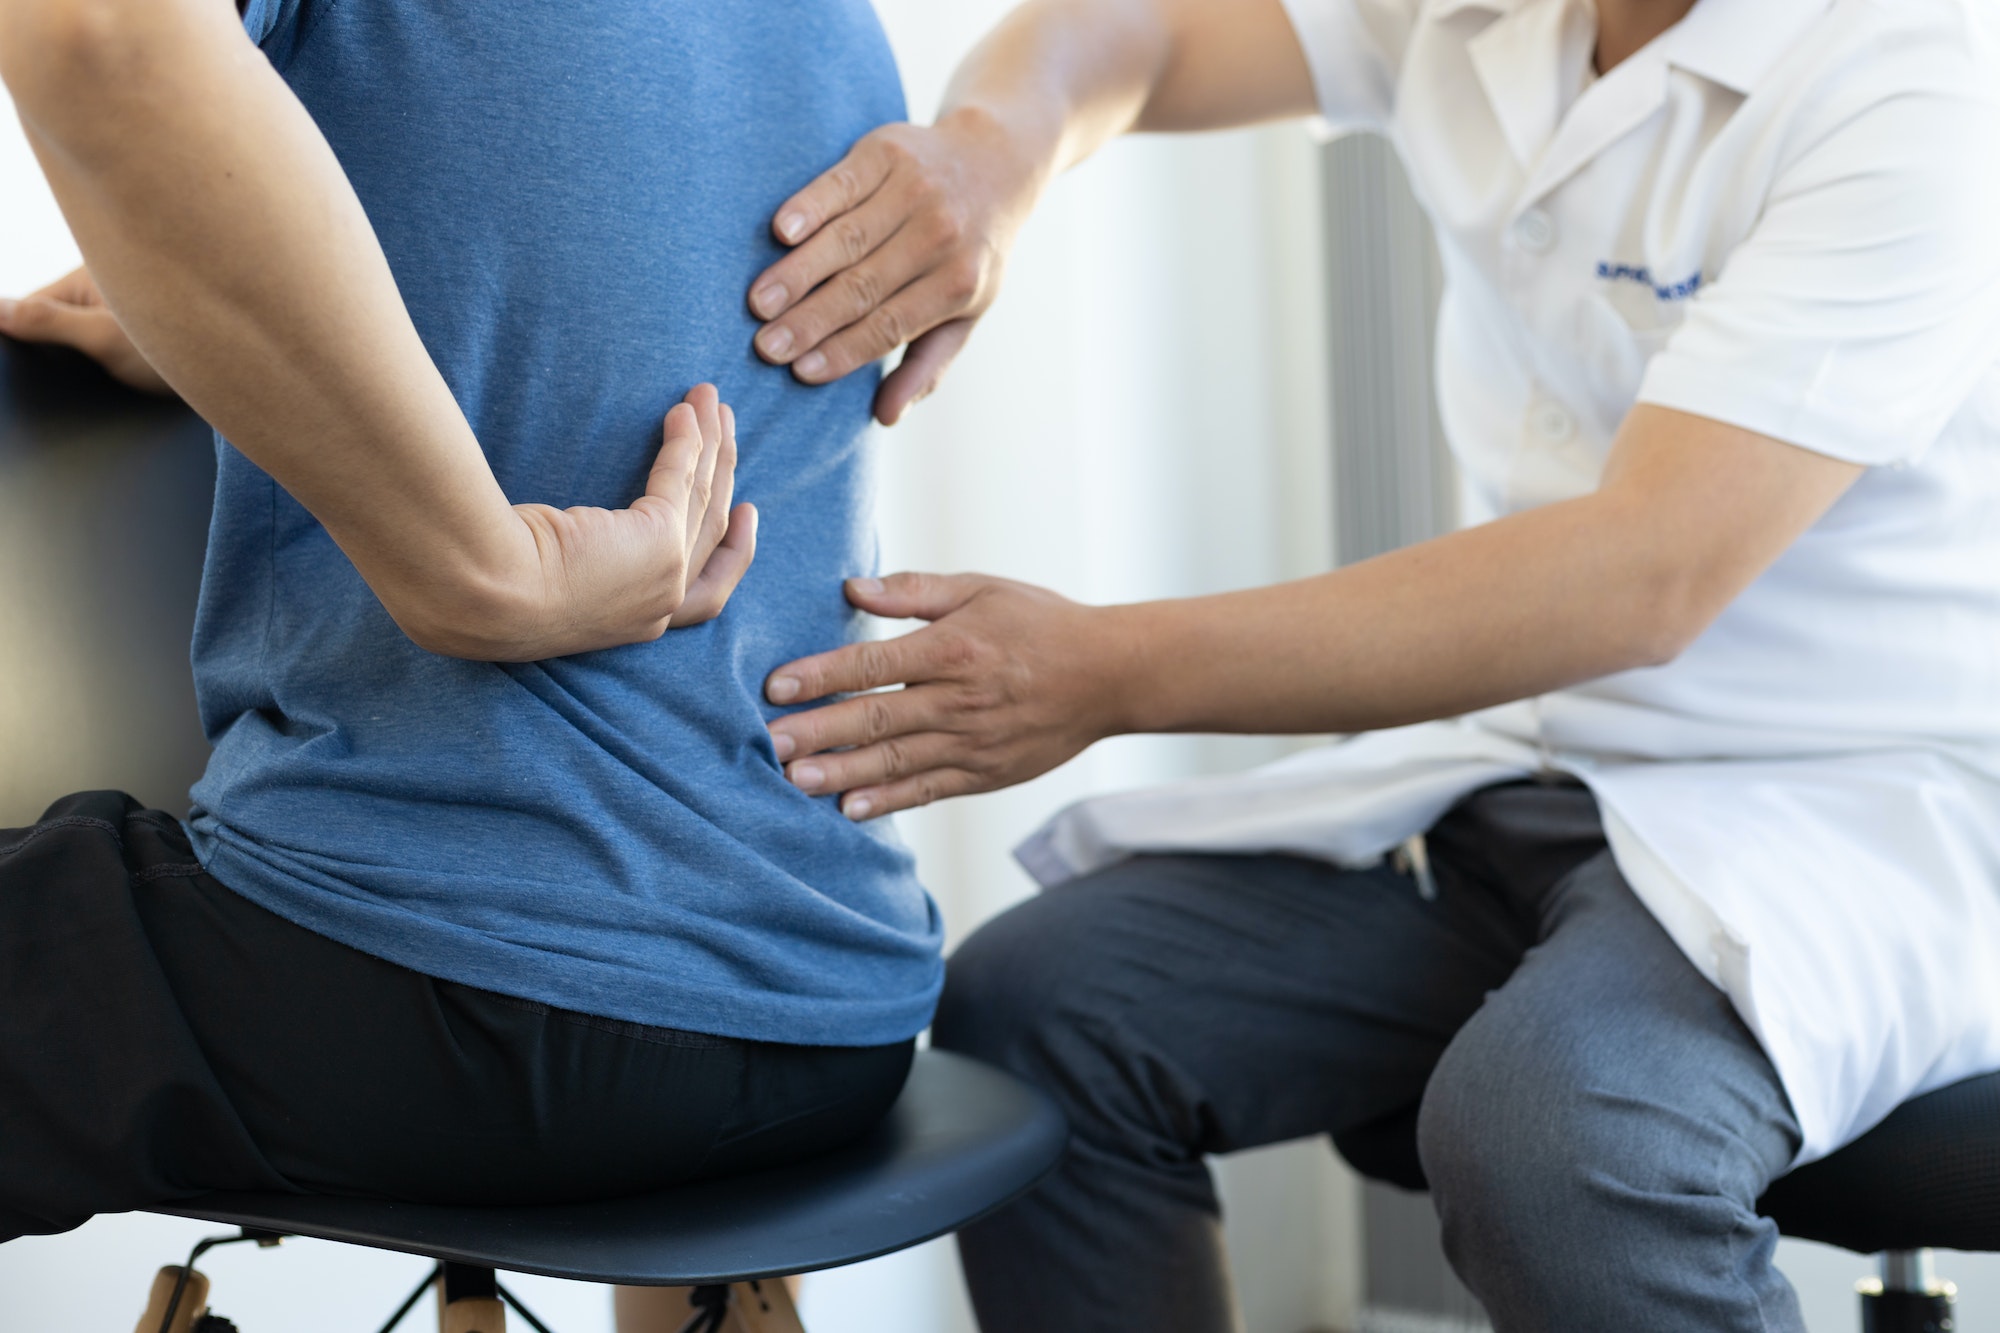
[190,0,942,1045]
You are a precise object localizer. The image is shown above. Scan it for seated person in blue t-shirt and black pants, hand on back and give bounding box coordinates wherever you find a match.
[0,0,940,1239]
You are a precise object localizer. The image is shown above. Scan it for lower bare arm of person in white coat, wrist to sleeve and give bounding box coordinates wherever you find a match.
[1108,406,1860,735]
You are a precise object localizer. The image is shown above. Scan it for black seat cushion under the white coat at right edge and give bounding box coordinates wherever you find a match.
[1760,1073,2000,1255]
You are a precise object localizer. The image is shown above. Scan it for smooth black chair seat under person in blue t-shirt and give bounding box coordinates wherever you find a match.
[154,1051,1070,1287]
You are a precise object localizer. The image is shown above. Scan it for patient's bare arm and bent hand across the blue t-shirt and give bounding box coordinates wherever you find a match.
[0,0,754,660]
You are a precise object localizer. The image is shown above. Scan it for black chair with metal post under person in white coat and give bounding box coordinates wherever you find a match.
[1334,1073,2000,1333]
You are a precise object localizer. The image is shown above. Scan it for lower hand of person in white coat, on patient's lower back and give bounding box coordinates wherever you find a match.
[764,574,1130,819]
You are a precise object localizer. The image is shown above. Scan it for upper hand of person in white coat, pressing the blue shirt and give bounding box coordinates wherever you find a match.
[750,108,1042,426]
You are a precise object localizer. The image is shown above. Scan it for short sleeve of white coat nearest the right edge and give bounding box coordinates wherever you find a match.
[1638,33,2000,466]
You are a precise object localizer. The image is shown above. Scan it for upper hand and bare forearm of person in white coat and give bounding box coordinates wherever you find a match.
[750,0,1314,426]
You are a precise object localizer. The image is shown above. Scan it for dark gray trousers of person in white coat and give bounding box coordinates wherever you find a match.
[934,783,1804,1333]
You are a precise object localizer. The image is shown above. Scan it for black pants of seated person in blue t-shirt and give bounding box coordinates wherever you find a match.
[0,793,912,1241]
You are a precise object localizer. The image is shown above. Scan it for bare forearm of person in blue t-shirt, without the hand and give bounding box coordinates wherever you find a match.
[0,0,536,644]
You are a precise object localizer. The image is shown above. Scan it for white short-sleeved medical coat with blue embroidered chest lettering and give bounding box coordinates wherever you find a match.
[1020,0,2000,1161]
